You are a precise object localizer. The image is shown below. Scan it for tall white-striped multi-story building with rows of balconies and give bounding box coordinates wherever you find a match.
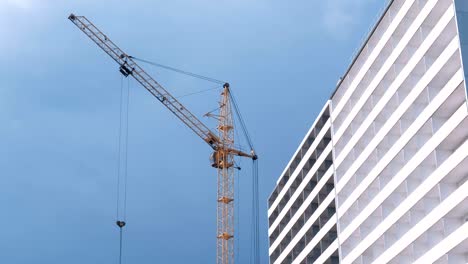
[268,0,468,264]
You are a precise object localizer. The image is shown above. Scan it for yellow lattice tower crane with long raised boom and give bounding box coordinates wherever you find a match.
[68,14,257,264]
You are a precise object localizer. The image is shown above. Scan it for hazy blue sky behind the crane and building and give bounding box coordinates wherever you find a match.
[0,0,384,264]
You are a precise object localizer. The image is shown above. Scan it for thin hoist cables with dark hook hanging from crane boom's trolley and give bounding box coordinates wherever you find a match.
[116,76,130,264]
